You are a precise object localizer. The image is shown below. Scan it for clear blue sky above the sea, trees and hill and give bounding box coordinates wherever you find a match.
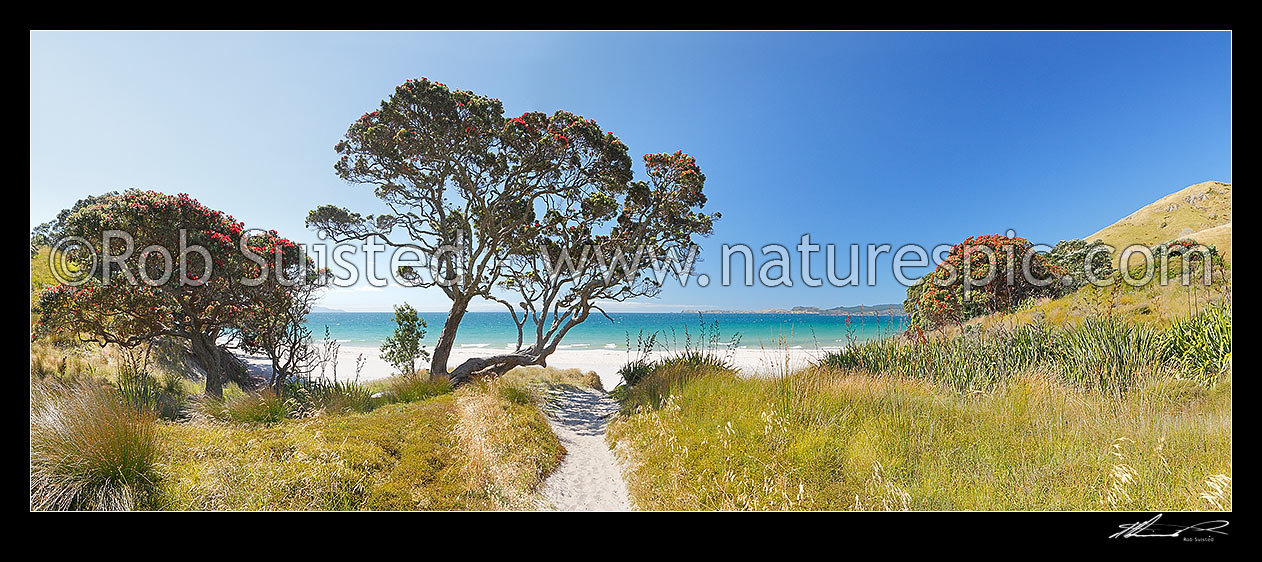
[30,32,1232,311]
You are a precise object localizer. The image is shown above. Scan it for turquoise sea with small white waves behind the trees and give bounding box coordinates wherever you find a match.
[308,312,906,350]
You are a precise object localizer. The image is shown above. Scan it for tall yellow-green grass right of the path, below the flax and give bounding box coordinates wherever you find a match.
[610,368,1232,510]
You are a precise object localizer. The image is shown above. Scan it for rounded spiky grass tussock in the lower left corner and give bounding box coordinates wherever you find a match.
[30,381,160,510]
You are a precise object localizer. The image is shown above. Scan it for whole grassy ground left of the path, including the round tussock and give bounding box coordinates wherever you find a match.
[30,344,580,510]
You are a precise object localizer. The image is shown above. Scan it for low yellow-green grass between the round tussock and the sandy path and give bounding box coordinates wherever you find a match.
[158,370,572,510]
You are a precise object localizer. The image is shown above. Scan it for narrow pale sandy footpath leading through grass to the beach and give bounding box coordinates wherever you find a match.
[541,386,631,511]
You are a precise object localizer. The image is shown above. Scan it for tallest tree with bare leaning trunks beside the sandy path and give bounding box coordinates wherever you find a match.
[307,78,718,384]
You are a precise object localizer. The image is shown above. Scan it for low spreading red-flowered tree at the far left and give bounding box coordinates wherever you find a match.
[37,189,303,397]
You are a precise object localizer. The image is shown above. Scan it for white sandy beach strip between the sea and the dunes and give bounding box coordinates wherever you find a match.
[242,346,827,389]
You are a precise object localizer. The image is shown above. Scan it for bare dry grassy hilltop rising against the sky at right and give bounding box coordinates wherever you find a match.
[1083,182,1232,260]
